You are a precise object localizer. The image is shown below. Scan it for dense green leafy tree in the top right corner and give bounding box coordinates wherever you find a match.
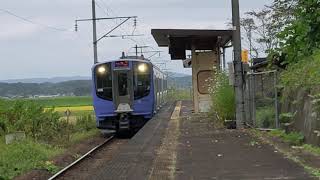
[277,0,320,64]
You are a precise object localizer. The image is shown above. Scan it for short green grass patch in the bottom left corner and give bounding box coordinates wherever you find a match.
[0,139,63,179]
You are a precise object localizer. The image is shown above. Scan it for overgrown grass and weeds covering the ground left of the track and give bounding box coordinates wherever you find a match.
[0,98,98,179]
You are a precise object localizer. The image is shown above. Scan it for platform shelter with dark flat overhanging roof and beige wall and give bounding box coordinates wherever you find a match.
[151,29,233,113]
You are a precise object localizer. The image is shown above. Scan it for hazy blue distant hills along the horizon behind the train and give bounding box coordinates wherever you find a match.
[0,72,192,97]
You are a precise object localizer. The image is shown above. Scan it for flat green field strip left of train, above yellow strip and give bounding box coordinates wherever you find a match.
[31,96,92,107]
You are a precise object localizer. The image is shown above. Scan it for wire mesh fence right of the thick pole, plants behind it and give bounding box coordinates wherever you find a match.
[244,71,279,129]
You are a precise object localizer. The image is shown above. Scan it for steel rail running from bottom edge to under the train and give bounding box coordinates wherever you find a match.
[48,135,115,180]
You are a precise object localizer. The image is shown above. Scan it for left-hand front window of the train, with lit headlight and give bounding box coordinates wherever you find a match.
[95,63,112,101]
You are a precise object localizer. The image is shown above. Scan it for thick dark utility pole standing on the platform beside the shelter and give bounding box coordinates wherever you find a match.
[231,0,245,129]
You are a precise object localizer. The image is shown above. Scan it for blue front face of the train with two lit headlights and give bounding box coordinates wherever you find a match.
[92,60,154,130]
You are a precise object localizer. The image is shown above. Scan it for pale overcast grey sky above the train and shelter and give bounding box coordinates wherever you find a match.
[0,0,271,80]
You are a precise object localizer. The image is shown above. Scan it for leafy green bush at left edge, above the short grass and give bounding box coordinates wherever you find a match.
[0,100,72,143]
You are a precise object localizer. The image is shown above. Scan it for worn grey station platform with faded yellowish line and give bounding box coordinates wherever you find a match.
[91,101,312,180]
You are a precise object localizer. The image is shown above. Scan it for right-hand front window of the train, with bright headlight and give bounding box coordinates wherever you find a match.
[133,62,151,100]
